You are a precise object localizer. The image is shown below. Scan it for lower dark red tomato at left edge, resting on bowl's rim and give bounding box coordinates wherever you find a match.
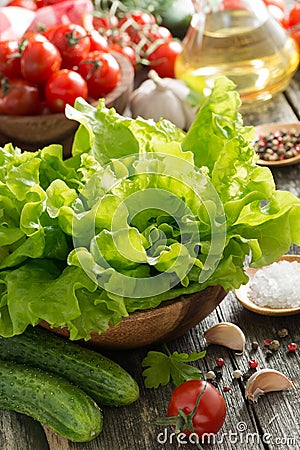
[0,78,40,116]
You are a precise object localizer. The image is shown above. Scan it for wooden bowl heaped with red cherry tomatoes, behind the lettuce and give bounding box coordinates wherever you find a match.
[0,24,134,153]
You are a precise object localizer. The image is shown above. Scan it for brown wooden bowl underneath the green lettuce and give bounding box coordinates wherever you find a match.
[40,286,226,349]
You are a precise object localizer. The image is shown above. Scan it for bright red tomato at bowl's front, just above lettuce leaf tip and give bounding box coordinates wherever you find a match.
[45,69,88,112]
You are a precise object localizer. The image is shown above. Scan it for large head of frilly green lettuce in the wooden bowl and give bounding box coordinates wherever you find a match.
[0,77,300,339]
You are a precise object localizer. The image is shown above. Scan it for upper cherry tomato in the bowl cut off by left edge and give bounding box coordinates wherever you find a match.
[0,41,21,78]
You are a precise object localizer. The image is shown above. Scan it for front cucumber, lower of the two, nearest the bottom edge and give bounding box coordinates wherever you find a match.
[0,361,103,442]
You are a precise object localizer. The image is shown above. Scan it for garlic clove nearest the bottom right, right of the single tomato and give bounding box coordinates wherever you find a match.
[245,369,293,402]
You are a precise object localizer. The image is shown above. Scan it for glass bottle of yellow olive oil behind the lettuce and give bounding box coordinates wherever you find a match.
[175,0,299,103]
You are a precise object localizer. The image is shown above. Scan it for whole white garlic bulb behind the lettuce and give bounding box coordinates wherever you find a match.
[129,70,197,130]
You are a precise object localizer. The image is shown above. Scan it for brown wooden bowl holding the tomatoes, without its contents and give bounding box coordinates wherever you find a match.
[0,53,134,156]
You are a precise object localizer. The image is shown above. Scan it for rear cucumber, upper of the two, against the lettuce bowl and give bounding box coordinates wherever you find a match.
[0,326,139,406]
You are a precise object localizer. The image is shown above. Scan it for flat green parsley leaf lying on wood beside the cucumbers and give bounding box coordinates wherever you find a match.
[142,345,206,388]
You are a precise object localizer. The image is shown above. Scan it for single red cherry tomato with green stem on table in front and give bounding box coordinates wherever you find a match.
[168,380,226,438]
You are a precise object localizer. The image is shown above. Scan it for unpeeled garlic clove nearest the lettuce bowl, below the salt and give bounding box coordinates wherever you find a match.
[204,322,246,353]
